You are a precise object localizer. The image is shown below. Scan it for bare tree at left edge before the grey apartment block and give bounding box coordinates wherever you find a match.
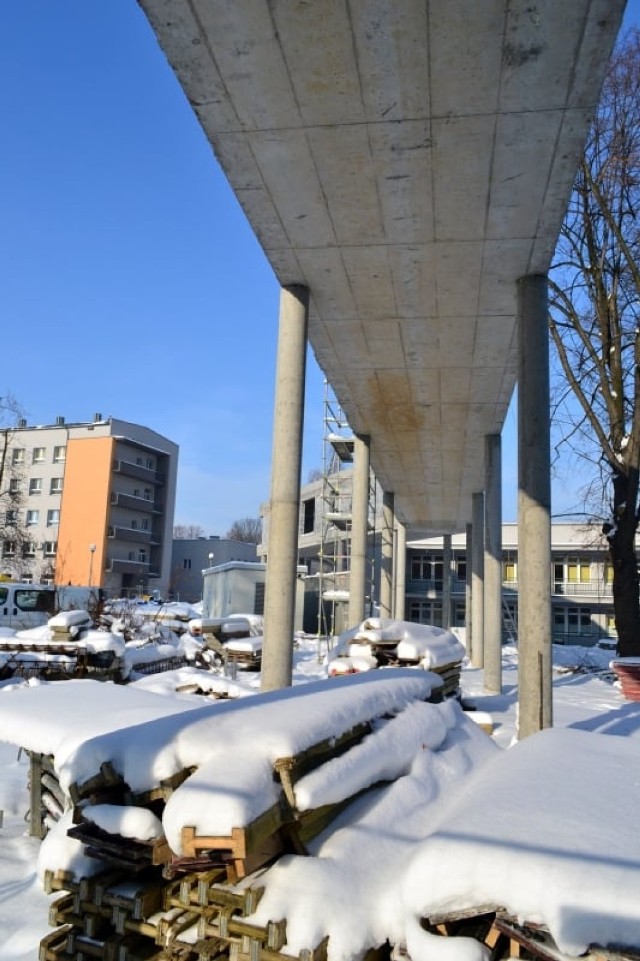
[0,394,29,577]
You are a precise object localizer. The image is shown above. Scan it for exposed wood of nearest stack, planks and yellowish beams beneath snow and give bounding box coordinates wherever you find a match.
[40,724,390,961]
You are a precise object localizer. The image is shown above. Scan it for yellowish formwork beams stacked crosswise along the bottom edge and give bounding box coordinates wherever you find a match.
[39,844,326,961]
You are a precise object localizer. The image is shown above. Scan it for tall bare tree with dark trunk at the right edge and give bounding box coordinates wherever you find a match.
[550,30,640,656]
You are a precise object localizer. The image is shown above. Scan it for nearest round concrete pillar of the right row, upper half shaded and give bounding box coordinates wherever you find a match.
[518,274,553,738]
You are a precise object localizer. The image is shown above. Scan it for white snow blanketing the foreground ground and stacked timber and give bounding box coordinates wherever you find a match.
[0,627,640,961]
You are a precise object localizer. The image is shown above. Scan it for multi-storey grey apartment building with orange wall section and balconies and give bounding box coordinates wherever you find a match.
[0,414,178,596]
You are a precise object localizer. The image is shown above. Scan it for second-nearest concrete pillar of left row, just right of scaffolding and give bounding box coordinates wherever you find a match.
[349,436,369,627]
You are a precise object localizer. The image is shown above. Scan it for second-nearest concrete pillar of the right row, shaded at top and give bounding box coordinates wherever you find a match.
[484,434,502,694]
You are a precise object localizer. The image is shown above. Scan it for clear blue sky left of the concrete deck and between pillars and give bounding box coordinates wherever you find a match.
[0,0,640,534]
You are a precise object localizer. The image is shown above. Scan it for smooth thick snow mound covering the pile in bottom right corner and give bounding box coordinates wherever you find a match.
[402,729,640,961]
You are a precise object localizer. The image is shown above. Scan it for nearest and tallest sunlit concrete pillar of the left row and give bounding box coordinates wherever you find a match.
[261,286,309,691]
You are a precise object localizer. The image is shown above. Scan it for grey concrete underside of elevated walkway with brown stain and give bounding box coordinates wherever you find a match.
[140,0,624,532]
